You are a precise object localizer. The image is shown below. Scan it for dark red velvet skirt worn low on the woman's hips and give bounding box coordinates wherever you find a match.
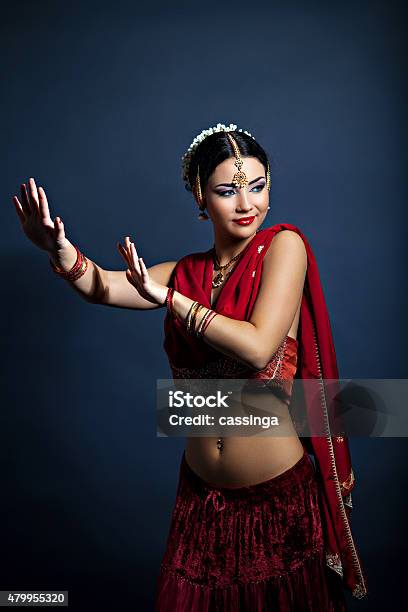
[155,452,346,612]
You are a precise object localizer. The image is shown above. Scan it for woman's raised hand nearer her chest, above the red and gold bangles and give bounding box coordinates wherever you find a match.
[118,236,168,306]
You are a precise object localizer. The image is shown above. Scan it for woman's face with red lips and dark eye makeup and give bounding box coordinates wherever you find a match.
[203,157,269,238]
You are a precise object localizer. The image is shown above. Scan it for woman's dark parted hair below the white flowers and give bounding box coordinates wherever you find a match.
[186,131,268,191]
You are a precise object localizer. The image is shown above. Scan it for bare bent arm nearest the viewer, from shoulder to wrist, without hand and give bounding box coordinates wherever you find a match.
[173,230,307,370]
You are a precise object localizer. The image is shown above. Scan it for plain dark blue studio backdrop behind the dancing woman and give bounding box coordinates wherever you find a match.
[0,0,407,611]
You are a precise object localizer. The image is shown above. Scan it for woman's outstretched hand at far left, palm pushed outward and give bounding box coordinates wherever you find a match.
[13,178,70,255]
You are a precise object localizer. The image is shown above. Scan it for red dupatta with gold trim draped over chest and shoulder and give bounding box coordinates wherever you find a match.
[163,223,367,599]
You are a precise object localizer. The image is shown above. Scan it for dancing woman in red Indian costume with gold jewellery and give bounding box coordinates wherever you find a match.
[13,124,366,612]
